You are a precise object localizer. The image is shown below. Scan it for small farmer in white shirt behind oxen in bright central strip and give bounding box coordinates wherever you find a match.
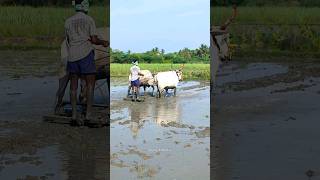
[130,60,143,101]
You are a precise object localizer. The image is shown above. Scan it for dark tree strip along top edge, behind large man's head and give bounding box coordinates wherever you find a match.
[0,0,104,7]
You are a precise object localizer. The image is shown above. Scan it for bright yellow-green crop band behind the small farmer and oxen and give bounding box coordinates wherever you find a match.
[110,63,210,80]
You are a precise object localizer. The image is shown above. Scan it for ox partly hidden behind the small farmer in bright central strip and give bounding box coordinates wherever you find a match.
[127,70,155,96]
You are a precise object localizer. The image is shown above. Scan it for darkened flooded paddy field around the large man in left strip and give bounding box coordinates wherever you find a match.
[0,51,109,180]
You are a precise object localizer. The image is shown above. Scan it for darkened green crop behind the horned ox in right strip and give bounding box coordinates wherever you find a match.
[211,7,320,58]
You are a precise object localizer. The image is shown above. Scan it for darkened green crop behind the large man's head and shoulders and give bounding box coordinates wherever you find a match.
[0,6,109,49]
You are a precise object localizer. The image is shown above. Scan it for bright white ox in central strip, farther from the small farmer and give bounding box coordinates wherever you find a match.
[154,69,182,98]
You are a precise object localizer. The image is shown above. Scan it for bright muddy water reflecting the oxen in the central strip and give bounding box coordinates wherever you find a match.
[110,79,210,179]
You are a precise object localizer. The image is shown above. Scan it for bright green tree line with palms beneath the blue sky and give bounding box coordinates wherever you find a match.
[110,44,210,64]
